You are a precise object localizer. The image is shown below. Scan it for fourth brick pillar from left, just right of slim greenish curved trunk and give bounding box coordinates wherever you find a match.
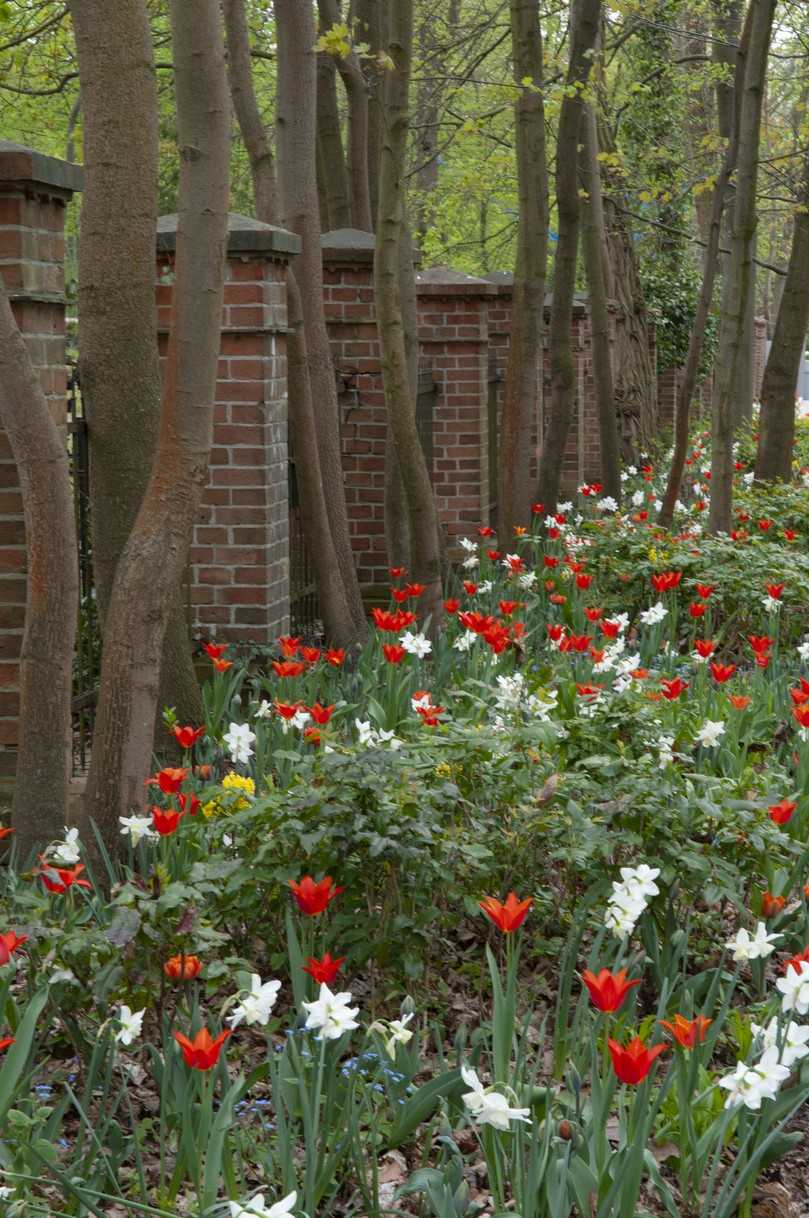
[417,267,497,548]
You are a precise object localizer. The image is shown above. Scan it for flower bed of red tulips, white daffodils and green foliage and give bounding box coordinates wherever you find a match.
[0,436,809,1218]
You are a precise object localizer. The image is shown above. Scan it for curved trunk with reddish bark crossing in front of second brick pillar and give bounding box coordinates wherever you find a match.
[85,0,230,851]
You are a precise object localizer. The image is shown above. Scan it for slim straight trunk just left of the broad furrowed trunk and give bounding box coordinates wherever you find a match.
[581,105,621,503]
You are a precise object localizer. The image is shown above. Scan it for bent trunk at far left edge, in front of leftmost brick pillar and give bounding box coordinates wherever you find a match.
[0,276,79,865]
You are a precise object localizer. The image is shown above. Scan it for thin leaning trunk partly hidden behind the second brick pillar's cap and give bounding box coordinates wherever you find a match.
[224,0,356,643]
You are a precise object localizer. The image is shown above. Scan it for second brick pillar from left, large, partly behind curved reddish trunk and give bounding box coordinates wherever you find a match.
[157,214,300,643]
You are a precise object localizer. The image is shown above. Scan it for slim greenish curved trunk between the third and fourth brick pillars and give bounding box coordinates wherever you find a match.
[374,0,441,628]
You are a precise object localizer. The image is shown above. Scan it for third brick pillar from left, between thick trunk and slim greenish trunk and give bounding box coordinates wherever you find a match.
[320,229,390,597]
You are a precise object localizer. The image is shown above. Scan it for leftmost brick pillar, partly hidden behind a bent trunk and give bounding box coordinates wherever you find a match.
[0,140,82,783]
